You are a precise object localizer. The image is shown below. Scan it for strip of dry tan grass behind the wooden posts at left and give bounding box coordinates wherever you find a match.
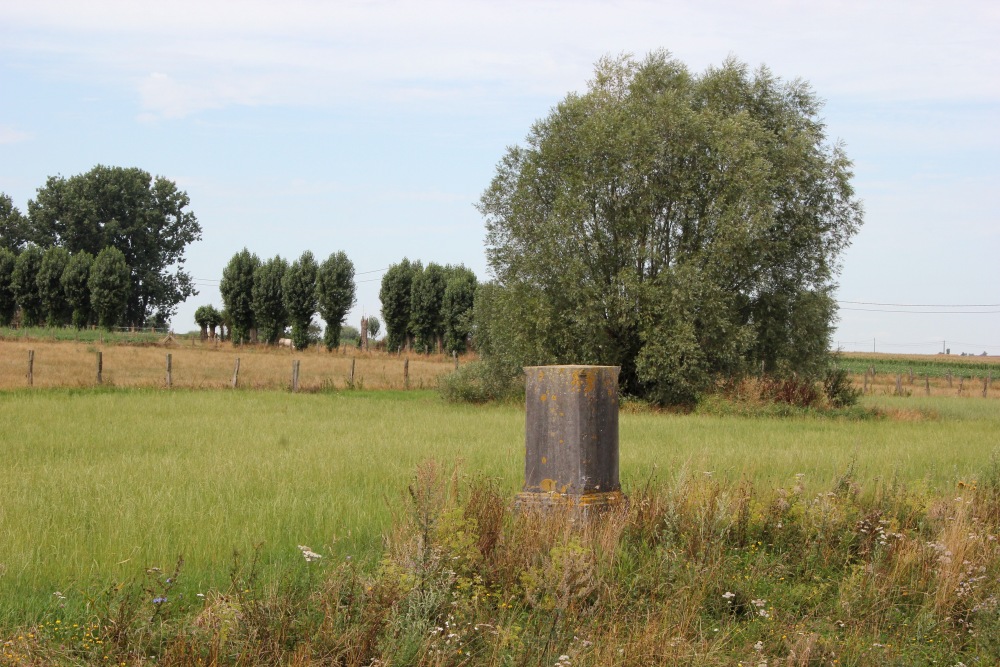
[0,340,454,391]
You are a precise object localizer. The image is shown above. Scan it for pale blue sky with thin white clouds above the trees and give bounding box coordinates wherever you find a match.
[0,0,1000,355]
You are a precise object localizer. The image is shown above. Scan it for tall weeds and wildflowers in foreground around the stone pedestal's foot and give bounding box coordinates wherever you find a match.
[2,461,1000,667]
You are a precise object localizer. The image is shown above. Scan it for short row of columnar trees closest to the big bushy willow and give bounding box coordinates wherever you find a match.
[379,258,479,354]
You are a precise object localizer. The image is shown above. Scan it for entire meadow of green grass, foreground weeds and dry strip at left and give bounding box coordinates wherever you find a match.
[0,341,1000,667]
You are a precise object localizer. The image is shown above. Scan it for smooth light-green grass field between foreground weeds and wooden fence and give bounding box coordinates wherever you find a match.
[0,390,1000,627]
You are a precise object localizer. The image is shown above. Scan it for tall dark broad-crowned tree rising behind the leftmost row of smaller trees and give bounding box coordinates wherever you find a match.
[28,165,201,324]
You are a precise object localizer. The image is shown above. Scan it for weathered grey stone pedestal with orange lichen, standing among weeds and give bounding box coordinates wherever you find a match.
[518,366,624,507]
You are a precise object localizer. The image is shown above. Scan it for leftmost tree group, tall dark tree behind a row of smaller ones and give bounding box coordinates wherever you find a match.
[0,165,201,327]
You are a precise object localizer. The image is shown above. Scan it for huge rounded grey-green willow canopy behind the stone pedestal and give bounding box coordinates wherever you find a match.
[477,52,862,403]
